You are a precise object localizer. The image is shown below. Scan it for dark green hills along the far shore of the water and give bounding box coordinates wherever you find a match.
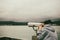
[0,19,60,25]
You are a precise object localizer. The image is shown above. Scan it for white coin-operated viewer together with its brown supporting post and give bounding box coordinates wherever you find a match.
[28,22,41,40]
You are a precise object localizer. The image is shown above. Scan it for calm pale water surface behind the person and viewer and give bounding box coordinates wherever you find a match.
[0,26,60,40]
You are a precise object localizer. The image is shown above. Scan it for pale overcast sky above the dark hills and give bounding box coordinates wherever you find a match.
[0,0,60,21]
